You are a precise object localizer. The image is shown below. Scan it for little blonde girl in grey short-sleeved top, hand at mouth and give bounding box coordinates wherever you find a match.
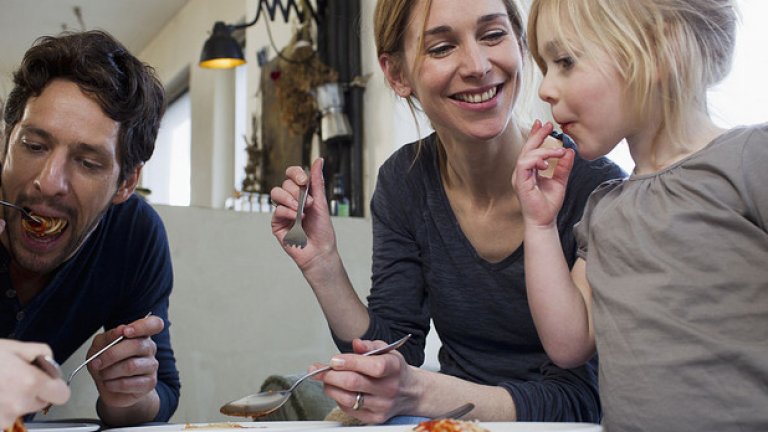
[514,0,768,432]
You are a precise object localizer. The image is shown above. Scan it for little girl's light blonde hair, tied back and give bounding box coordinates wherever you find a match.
[528,0,738,145]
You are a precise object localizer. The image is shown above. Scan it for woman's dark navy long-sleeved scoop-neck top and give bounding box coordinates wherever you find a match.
[334,134,624,422]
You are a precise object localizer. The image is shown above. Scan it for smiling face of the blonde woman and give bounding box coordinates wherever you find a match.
[394,0,522,140]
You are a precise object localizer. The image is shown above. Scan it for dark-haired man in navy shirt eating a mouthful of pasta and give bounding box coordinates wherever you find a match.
[0,31,180,426]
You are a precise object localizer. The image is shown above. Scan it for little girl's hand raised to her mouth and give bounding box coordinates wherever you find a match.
[512,120,575,227]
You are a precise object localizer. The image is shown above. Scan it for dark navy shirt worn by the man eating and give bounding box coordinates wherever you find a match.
[0,195,181,421]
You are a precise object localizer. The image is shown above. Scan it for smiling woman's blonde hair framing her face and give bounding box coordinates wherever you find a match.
[373,0,527,157]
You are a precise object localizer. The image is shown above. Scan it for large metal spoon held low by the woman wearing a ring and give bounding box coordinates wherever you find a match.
[219,334,411,417]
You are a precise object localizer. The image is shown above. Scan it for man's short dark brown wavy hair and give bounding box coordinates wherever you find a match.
[3,30,165,185]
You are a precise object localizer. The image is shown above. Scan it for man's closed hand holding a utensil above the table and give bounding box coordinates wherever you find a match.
[88,316,164,425]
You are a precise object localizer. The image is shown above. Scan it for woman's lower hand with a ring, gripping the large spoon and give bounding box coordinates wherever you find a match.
[315,339,418,424]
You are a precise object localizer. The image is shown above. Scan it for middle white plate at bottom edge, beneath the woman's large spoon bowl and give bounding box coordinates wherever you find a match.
[104,421,341,432]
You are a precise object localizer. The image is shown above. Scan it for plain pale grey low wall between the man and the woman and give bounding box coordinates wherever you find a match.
[44,206,371,423]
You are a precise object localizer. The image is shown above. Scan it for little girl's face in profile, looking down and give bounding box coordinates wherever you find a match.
[536,18,640,159]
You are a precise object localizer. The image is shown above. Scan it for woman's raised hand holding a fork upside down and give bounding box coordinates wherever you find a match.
[270,159,336,271]
